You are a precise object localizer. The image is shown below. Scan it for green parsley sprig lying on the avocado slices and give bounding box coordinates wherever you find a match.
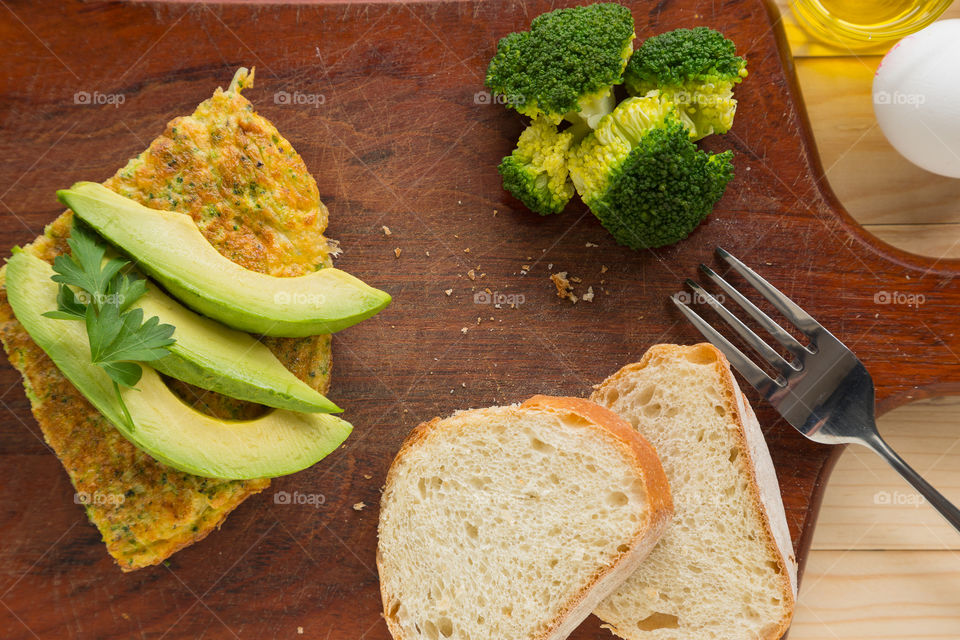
[43,221,175,429]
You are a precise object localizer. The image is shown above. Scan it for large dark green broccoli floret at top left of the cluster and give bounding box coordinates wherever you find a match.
[486,3,636,126]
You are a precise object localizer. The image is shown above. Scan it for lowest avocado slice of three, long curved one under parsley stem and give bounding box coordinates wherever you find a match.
[6,251,352,480]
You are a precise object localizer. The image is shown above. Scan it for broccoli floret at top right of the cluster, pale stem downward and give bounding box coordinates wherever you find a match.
[624,27,747,140]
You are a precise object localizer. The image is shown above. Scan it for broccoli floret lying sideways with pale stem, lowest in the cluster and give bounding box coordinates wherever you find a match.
[569,93,733,249]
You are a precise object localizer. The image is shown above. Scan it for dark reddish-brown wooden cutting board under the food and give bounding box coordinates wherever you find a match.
[0,0,960,640]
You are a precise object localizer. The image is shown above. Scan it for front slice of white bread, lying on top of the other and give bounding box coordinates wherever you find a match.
[377,396,673,640]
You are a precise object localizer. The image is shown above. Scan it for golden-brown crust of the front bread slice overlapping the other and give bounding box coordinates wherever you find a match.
[377,395,673,640]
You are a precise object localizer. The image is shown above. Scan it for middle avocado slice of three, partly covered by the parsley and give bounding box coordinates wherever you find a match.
[16,252,341,413]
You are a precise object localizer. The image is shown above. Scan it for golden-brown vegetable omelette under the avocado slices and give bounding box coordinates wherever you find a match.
[0,69,336,571]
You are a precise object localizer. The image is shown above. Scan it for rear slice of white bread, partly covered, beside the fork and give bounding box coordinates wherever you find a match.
[591,344,797,640]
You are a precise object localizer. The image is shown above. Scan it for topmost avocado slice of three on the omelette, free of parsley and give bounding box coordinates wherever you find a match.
[57,182,390,338]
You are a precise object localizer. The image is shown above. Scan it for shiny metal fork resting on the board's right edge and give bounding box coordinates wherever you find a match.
[671,247,960,531]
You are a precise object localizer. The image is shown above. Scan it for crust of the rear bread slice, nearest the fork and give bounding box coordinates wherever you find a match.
[590,342,797,640]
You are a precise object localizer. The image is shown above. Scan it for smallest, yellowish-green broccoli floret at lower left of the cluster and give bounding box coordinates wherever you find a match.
[498,117,575,215]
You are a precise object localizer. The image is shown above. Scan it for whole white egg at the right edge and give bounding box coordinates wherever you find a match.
[873,20,960,178]
